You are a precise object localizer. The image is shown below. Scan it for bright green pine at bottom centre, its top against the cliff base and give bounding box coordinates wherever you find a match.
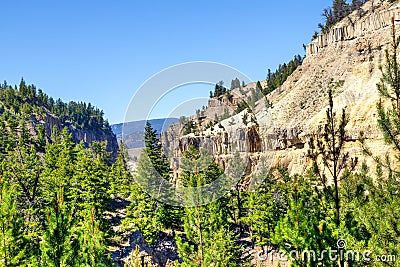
[176,147,238,266]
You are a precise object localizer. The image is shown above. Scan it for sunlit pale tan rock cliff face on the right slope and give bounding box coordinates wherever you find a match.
[161,0,400,182]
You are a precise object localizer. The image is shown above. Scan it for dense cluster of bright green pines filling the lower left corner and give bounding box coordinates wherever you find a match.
[0,107,115,266]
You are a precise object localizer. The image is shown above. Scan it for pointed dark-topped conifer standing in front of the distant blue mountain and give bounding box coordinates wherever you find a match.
[123,123,181,244]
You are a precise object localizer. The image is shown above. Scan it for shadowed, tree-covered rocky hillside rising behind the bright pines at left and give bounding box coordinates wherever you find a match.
[0,79,118,157]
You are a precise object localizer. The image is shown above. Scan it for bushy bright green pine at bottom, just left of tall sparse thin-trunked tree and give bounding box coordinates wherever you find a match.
[272,176,337,266]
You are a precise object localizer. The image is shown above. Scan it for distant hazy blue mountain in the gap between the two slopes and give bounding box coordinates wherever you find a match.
[111,118,179,148]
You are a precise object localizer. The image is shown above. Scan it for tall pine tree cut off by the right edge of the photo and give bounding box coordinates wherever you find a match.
[357,19,400,266]
